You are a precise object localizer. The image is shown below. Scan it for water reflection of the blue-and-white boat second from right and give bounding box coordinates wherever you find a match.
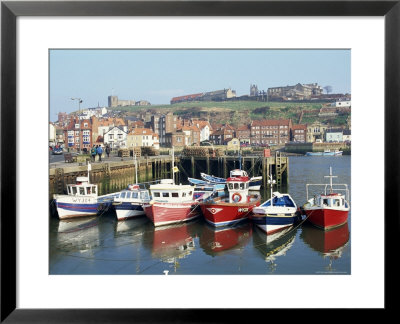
[253,227,297,272]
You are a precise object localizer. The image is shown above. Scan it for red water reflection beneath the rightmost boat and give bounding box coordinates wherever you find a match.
[300,223,350,271]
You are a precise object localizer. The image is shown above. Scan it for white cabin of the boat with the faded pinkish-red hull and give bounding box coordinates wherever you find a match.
[150,179,194,203]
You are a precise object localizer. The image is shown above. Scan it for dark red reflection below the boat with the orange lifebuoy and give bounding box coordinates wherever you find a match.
[200,222,252,256]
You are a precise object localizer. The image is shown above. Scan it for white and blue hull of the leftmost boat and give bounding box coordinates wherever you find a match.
[55,196,99,219]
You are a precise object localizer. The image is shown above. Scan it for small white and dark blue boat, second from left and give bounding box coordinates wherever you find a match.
[113,184,151,220]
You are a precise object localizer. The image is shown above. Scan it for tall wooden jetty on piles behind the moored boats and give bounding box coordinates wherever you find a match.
[49,152,289,200]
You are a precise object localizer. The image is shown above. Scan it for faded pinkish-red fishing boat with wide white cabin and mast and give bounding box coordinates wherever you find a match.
[144,150,200,226]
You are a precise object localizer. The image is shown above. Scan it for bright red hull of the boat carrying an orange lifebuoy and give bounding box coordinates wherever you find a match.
[201,200,260,227]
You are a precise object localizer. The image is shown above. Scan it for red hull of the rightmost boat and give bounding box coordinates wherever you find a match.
[304,208,349,230]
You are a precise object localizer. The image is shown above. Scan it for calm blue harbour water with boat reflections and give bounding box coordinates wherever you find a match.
[49,156,351,275]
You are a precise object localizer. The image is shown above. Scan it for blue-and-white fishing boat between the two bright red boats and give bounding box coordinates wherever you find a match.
[251,176,300,234]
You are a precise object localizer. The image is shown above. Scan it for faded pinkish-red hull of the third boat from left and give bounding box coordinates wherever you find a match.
[144,202,200,226]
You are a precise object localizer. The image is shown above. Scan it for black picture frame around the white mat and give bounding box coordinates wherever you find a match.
[0,0,400,323]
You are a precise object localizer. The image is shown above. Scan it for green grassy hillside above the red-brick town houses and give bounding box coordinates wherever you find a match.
[112,101,350,126]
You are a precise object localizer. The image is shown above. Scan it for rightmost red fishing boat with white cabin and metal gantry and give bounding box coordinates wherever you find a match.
[302,167,350,230]
